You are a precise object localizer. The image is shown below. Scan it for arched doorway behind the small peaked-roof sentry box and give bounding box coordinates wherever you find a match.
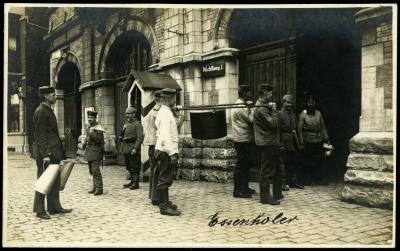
[105,31,152,163]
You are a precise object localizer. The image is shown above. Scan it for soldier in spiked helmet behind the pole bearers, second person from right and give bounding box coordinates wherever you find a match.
[279,95,304,190]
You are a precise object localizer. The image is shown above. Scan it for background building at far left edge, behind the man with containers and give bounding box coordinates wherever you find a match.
[4,7,49,154]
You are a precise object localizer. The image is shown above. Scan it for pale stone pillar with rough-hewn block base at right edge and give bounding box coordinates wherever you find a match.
[342,7,394,208]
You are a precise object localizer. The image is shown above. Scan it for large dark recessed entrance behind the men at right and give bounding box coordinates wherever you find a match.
[227,8,361,180]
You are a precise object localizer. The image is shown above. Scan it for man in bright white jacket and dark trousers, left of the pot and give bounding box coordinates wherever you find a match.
[152,88,181,216]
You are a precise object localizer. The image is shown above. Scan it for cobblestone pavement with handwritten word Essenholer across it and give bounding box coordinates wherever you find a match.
[3,155,393,247]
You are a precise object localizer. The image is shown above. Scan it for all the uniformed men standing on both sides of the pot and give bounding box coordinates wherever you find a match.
[33,84,329,219]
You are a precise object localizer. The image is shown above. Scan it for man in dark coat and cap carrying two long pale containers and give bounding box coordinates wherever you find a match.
[33,86,72,220]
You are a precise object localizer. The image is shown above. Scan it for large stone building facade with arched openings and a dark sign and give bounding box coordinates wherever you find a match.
[22,7,393,210]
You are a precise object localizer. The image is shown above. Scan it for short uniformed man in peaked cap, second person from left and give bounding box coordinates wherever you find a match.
[83,111,104,195]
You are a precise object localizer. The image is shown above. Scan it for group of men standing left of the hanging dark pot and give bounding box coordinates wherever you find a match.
[33,86,183,219]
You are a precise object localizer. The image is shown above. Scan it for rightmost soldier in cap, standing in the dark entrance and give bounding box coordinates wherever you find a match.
[298,95,329,185]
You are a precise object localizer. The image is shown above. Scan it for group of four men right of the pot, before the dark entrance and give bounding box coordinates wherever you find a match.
[232,84,329,205]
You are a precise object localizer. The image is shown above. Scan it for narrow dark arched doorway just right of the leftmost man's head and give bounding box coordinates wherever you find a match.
[57,62,82,158]
